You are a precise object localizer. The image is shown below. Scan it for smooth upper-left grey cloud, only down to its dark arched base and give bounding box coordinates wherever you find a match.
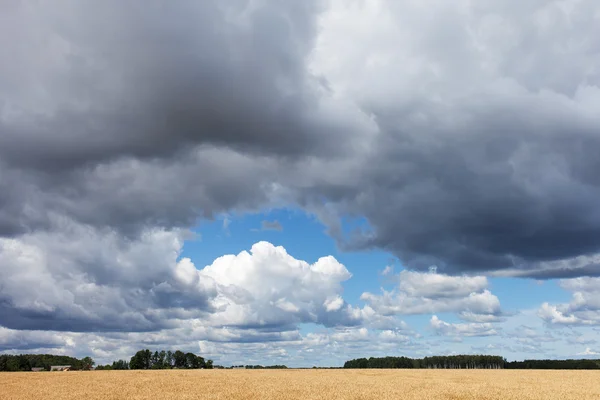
[0,1,336,170]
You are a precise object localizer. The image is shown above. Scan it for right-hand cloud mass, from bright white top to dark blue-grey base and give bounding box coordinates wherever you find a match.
[292,1,600,278]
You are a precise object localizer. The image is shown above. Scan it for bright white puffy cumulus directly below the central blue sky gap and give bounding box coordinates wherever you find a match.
[199,242,360,327]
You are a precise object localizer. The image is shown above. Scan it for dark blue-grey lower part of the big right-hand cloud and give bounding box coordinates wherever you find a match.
[336,111,600,275]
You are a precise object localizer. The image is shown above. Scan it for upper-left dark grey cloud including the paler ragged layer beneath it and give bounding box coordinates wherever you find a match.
[0,1,344,236]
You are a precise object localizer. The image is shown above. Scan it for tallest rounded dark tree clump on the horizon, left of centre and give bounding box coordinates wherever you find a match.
[125,349,213,369]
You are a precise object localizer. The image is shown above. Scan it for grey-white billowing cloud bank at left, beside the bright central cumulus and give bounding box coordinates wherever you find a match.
[0,220,216,331]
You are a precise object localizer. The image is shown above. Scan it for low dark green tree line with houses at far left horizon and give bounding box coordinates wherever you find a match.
[0,354,95,372]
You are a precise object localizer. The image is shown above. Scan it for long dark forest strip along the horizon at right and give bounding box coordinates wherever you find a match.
[344,355,600,369]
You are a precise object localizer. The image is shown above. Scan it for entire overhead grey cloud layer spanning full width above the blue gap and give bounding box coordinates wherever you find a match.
[0,0,600,312]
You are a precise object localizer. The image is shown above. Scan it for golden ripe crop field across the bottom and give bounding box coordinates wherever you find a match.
[0,369,600,400]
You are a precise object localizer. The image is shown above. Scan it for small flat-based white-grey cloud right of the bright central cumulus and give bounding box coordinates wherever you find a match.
[361,270,503,322]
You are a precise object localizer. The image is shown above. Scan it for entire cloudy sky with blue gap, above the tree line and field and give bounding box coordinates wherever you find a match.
[0,0,600,367]
